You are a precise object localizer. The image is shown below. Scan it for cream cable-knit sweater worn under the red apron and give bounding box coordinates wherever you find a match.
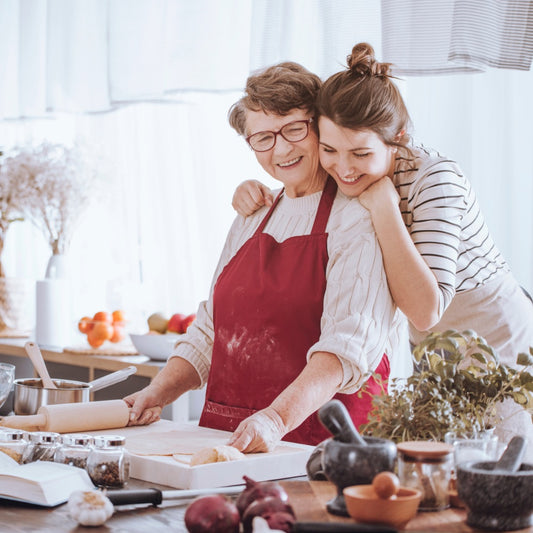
[171,185,397,394]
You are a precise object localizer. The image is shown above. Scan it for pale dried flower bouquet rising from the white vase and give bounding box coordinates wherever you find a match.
[0,142,97,255]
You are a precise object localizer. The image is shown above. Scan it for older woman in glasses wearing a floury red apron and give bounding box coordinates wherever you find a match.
[126,63,396,452]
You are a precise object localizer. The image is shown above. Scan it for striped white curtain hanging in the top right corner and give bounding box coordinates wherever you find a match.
[381,0,533,76]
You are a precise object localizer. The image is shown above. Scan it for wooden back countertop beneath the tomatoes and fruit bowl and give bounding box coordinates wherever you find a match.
[0,338,164,381]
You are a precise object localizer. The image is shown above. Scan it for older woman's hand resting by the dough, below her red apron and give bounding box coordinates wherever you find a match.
[228,407,287,453]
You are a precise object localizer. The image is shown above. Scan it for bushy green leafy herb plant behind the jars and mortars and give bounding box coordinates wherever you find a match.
[360,330,533,442]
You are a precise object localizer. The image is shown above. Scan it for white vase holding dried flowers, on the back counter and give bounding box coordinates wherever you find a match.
[35,254,72,348]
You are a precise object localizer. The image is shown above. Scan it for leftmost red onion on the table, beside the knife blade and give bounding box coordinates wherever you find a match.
[185,494,240,533]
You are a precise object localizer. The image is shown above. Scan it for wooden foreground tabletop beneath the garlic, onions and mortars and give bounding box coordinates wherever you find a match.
[0,480,533,533]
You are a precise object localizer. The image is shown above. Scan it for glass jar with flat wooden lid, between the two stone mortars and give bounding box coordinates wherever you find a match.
[397,441,453,511]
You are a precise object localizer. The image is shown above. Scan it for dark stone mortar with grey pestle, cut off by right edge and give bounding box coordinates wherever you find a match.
[456,436,533,531]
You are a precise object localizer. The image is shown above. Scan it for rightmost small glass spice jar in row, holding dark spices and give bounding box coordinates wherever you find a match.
[87,435,130,487]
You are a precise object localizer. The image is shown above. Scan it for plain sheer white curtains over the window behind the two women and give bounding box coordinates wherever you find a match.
[0,0,533,344]
